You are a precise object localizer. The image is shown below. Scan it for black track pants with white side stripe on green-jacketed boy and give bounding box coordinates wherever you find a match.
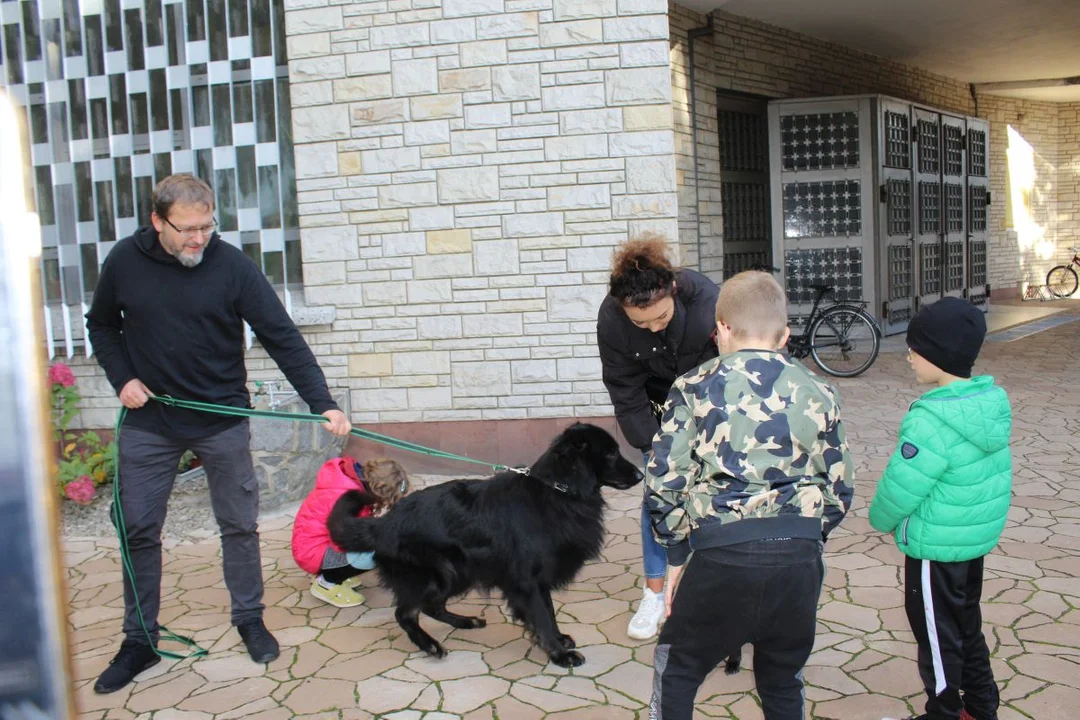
[904,557,1000,720]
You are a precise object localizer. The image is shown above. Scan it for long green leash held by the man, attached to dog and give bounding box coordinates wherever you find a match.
[112,395,520,660]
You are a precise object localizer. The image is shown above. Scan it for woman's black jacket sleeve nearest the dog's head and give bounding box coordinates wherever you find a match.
[596,317,660,451]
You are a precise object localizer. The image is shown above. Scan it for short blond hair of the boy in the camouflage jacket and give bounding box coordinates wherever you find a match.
[716,270,787,343]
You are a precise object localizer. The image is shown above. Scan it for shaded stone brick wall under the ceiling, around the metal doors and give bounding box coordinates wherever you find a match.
[670,3,1078,293]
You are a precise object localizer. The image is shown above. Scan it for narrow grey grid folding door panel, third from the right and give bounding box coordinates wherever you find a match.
[913,108,945,311]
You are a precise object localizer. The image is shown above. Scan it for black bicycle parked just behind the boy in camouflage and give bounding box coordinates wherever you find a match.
[750,266,881,378]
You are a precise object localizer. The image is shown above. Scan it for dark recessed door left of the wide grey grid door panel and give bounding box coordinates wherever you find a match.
[716,92,772,277]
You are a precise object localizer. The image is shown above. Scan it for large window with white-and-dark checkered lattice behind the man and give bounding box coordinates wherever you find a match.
[0,0,302,357]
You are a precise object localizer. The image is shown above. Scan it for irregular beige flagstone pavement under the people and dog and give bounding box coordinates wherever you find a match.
[65,302,1080,720]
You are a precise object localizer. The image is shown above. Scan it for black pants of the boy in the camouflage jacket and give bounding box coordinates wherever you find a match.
[649,539,825,720]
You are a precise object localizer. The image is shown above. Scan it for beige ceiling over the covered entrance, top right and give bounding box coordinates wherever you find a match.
[676,0,1080,101]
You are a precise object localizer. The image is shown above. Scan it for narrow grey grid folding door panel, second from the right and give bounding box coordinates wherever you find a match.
[941,114,968,298]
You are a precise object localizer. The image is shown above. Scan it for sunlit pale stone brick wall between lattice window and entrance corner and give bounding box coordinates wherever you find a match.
[286,0,677,422]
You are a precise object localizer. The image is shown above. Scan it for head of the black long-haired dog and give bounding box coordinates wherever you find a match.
[531,422,644,497]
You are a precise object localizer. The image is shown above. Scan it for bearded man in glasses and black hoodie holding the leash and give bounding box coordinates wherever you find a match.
[86,174,351,693]
